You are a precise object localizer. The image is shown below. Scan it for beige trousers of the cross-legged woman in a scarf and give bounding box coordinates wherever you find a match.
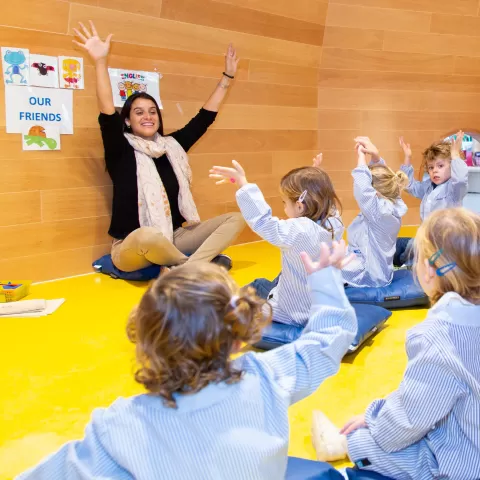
[112,212,245,272]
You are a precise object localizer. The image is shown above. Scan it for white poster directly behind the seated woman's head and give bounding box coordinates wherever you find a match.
[108,68,162,108]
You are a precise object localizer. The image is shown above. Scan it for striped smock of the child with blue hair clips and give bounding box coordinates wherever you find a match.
[348,292,480,480]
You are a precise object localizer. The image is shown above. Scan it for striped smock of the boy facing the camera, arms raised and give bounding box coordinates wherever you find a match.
[400,158,468,220]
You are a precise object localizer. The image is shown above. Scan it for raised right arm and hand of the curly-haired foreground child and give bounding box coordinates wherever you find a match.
[238,240,357,403]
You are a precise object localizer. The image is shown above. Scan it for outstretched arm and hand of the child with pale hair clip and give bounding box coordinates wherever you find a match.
[210,160,312,248]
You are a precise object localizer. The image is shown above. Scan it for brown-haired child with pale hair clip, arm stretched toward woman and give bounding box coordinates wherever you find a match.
[210,160,340,327]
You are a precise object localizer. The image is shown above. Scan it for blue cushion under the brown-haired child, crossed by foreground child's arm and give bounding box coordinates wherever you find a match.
[255,304,392,354]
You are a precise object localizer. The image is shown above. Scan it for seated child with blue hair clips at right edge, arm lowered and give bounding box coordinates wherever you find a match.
[314,208,480,480]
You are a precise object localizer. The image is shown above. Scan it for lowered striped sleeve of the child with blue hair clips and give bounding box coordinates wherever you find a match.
[344,334,465,457]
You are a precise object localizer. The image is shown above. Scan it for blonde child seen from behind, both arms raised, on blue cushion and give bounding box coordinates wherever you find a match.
[342,137,408,287]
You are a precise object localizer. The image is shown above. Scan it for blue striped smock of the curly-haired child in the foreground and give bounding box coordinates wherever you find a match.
[17,268,357,480]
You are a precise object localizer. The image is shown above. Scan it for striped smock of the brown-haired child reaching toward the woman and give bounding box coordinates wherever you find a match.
[237,183,344,327]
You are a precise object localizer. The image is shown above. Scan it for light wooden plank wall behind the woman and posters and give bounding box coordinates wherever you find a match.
[4,0,480,281]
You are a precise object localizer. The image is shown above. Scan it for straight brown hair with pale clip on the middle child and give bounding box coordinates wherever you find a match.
[280,167,342,238]
